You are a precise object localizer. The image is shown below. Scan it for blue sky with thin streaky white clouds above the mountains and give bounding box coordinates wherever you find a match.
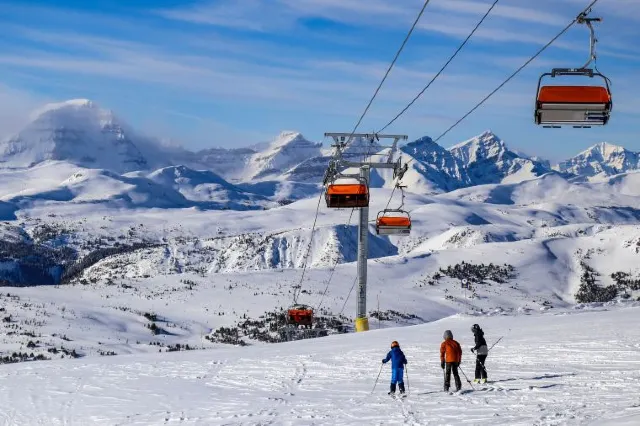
[0,0,640,161]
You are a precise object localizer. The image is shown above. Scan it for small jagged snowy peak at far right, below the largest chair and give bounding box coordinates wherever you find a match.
[558,142,640,178]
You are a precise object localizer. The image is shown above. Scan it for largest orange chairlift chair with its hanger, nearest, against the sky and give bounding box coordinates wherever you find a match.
[535,14,613,128]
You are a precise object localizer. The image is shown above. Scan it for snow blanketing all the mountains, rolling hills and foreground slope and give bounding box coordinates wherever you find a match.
[0,100,640,424]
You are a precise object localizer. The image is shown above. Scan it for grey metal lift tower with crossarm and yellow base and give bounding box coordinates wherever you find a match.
[324,133,408,332]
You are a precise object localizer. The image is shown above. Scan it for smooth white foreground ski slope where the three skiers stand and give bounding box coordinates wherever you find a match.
[0,302,640,426]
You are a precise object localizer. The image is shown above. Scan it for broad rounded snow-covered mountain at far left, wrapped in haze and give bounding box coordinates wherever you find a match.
[0,99,149,173]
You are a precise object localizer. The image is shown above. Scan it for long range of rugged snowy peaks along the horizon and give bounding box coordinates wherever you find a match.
[0,99,640,198]
